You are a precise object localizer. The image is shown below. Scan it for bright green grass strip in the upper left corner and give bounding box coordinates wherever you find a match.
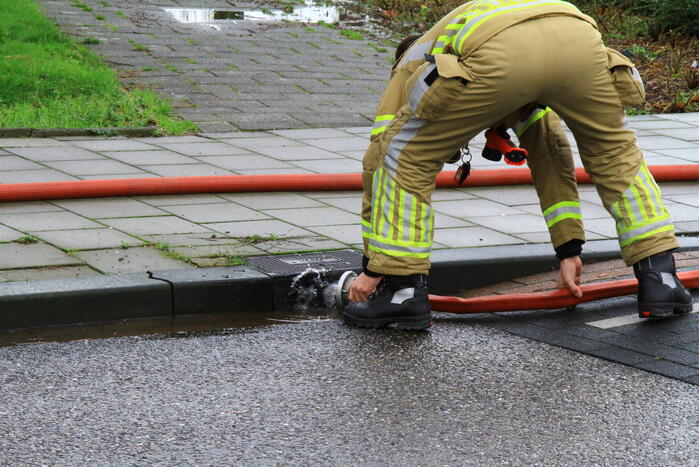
[0,0,196,134]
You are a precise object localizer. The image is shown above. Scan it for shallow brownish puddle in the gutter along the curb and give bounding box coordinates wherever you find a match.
[0,309,337,347]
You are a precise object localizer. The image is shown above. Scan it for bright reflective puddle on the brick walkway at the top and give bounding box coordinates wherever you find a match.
[165,0,340,29]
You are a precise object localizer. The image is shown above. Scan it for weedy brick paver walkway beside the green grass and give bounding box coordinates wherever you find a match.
[39,0,393,131]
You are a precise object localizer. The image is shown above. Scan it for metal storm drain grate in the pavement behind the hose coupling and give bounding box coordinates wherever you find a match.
[247,250,362,274]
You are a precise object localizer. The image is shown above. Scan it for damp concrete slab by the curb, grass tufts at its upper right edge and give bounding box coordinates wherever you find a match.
[75,247,192,274]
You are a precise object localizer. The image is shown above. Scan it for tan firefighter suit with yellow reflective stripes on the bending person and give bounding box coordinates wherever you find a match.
[362,0,678,275]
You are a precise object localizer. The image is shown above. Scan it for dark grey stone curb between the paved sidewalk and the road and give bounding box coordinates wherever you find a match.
[0,237,699,331]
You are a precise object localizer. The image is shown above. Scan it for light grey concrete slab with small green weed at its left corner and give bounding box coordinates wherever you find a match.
[35,229,143,250]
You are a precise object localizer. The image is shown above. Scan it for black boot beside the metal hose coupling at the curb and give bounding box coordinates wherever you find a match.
[342,274,432,330]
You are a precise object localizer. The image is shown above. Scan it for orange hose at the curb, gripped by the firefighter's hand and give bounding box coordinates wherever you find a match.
[430,271,699,314]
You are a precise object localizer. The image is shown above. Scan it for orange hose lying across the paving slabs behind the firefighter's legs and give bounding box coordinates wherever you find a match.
[0,164,699,202]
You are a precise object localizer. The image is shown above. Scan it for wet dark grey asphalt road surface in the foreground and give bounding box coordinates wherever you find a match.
[0,319,699,466]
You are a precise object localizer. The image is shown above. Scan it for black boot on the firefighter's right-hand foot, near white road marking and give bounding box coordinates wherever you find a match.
[633,251,693,318]
